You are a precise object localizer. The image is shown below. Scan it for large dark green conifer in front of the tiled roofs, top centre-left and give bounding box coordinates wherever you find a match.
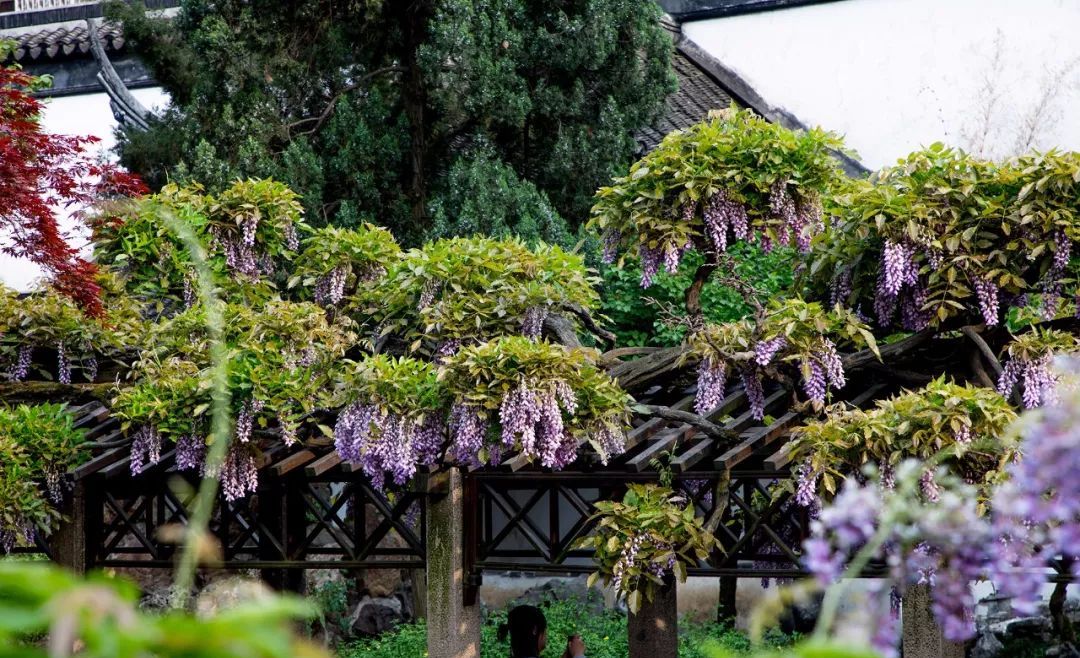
[110,0,674,243]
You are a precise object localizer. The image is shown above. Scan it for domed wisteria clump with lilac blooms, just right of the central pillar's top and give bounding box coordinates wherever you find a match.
[444,337,631,469]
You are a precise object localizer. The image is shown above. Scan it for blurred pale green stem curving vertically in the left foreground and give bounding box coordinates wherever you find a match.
[162,213,232,608]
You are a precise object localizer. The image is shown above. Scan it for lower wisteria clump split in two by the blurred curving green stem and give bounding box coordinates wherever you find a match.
[111,301,354,497]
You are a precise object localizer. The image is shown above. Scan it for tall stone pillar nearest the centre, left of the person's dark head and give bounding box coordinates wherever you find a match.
[427,468,481,658]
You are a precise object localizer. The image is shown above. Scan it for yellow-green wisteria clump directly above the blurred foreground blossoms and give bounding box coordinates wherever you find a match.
[788,378,1017,510]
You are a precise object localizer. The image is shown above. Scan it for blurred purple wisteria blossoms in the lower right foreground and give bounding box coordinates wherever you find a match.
[804,358,1080,641]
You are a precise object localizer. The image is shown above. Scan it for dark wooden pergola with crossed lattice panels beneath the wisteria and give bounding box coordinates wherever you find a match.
[12,369,911,657]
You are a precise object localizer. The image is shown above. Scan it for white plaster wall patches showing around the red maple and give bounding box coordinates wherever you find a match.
[0,88,167,292]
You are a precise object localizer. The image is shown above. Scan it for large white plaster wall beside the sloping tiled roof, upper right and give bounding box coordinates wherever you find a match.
[683,0,1080,169]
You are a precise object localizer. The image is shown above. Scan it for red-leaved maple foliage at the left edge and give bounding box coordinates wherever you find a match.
[0,54,146,315]
